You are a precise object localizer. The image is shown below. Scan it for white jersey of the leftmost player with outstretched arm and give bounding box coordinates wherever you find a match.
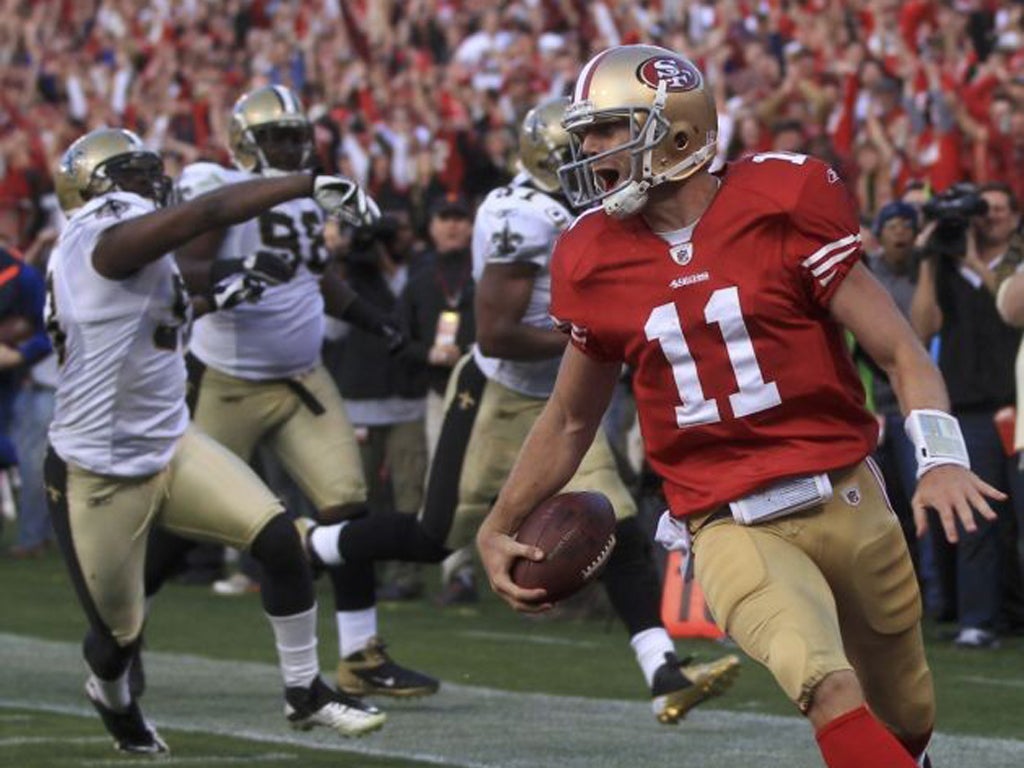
[46,191,191,477]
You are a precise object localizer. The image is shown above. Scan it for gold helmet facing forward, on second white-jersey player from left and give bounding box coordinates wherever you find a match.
[227,85,313,173]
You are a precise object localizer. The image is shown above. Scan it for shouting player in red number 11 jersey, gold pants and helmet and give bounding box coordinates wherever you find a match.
[477,46,1002,768]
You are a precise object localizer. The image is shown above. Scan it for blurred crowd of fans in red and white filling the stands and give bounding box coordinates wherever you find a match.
[0,0,1024,259]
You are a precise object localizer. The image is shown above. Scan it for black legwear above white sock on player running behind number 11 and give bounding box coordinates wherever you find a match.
[601,517,662,637]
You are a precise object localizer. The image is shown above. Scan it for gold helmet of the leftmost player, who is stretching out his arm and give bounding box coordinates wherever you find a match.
[53,128,171,213]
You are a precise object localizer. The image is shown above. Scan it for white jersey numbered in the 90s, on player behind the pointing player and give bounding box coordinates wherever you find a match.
[178,163,327,381]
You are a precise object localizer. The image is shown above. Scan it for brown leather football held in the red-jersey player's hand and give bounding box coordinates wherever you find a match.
[512,492,615,602]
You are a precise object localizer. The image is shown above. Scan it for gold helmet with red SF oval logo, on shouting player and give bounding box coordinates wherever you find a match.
[558,45,718,216]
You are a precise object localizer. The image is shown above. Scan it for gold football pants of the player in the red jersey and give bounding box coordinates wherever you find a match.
[687,460,935,736]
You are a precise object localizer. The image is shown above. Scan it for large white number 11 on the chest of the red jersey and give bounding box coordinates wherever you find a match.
[644,287,782,429]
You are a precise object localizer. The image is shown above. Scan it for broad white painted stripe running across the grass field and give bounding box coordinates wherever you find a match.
[0,634,1024,768]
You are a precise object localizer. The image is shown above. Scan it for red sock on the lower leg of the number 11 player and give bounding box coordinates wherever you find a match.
[815,707,916,768]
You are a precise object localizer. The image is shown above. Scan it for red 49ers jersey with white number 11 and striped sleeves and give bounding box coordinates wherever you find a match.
[551,153,878,516]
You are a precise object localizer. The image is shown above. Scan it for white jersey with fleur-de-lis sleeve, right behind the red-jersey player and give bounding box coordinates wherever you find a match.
[473,173,572,397]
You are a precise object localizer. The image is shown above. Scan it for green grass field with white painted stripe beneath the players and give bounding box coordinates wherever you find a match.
[0,532,1024,768]
